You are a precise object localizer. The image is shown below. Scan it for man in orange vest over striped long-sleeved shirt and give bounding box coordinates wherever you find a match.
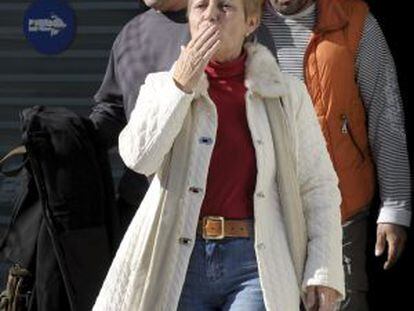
[258,0,411,310]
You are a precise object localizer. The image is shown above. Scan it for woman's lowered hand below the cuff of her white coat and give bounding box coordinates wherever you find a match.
[305,286,340,311]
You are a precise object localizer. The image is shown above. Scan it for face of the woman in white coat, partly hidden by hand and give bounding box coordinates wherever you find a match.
[188,0,259,62]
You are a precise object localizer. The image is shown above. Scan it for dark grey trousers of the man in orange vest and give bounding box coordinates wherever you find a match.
[340,211,368,311]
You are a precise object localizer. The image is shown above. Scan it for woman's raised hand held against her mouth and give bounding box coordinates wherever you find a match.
[173,25,220,93]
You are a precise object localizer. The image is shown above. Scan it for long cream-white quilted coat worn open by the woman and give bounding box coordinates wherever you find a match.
[94,44,344,311]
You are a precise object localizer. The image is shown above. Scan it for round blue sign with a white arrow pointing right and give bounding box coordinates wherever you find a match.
[23,0,76,54]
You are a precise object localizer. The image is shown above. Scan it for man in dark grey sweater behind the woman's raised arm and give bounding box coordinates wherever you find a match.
[90,0,189,229]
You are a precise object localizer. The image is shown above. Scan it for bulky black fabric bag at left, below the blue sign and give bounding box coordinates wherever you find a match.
[0,107,121,311]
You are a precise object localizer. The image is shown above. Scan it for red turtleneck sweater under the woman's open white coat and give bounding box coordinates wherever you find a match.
[201,53,256,219]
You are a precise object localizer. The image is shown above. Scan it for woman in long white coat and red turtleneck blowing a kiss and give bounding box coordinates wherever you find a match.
[95,0,344,311]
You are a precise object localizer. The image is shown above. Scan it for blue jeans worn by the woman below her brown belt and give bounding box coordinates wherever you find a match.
[178,237,266,311]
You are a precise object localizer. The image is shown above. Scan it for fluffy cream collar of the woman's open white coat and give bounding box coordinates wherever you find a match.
[195,43,286,98]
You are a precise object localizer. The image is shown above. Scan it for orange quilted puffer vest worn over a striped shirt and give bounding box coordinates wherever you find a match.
[304,0,375,221]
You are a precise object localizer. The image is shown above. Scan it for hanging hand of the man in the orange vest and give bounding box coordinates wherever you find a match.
[375,223,407,270]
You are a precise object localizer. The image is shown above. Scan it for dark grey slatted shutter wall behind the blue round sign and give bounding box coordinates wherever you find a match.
[0,0,137,225]
